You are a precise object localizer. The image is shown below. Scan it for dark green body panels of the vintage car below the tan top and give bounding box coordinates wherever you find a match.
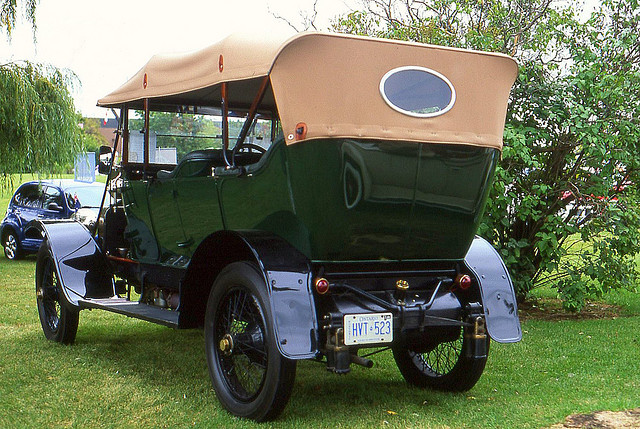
[124,139,499,264]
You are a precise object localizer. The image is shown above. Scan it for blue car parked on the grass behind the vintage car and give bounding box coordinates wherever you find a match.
[0,179,105,259]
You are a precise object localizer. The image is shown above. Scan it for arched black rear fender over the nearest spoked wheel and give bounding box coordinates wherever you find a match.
[180,230,318,359]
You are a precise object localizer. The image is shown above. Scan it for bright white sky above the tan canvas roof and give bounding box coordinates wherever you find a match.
[0,0,598,117]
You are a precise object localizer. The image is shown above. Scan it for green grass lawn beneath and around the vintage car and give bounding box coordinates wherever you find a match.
[0,249,640,428]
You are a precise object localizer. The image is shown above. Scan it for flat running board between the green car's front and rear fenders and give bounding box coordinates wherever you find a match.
[78,298,180,328]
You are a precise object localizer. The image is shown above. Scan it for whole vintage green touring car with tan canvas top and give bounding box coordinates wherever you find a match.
[36,33,521,421]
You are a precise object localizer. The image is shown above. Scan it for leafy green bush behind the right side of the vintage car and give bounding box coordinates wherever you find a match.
[333,0,640,309]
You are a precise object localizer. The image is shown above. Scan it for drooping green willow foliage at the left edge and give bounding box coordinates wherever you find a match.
[0,0,82,184]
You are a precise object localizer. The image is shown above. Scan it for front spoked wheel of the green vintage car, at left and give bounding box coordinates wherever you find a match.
[36,242,79,344]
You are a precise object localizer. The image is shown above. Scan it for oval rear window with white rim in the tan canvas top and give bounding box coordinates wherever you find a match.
[380,66,456,118]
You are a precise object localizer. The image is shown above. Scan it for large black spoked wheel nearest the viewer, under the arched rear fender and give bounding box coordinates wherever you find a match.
[204,262,296,421]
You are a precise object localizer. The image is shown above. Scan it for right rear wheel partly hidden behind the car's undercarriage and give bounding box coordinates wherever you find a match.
[392,329,489,392]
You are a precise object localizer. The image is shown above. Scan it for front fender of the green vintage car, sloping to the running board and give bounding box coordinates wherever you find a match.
[40,221,114,306]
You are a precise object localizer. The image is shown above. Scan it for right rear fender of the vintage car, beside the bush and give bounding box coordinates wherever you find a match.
[465,237,522,343]
